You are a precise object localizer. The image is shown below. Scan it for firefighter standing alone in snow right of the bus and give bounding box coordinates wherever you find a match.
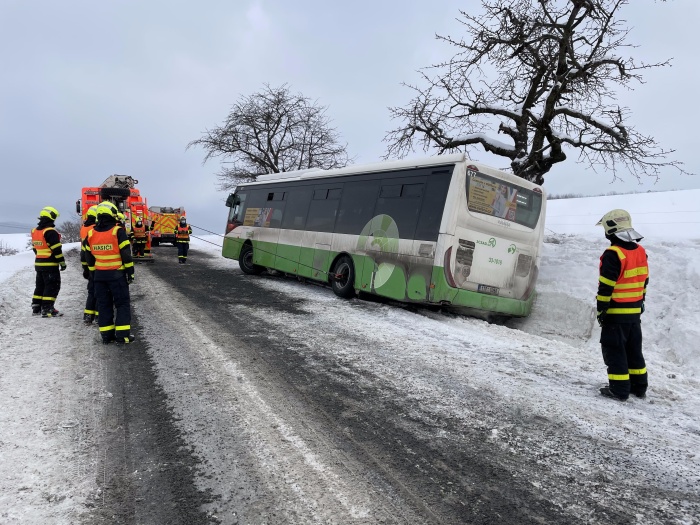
[597,210,649,401]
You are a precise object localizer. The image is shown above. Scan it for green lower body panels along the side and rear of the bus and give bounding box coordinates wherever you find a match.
[222,232,535,319]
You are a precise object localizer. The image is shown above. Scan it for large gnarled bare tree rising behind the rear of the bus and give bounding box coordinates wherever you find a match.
[385,0,685,184]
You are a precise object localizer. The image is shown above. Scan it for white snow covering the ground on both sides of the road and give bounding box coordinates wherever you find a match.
[0,190,700,523]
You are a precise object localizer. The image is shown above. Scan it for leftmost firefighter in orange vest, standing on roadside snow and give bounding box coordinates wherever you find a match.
[31,206,66,317]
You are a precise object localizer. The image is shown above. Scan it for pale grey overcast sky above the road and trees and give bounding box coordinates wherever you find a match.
[0,0,700,234]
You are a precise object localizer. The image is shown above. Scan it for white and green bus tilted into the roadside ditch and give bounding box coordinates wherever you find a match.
[222,153,546,320]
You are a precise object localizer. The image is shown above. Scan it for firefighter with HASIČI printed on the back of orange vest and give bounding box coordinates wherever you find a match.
[85,201,134,345]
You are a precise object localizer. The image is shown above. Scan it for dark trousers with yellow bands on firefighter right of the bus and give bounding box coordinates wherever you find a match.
[600,322,647,397]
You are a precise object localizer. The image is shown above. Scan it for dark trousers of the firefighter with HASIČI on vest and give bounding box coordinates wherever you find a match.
[95,275,131,340]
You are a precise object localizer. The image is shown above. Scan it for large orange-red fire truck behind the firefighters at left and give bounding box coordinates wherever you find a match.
[75,174,153,262]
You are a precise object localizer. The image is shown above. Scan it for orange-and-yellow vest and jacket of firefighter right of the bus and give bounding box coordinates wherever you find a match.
[597,245,649,322]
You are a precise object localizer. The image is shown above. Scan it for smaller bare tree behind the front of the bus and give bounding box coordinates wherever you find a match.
[187,84,351,190]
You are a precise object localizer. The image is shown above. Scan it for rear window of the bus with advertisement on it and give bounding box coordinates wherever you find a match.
[467,170,542,228]
